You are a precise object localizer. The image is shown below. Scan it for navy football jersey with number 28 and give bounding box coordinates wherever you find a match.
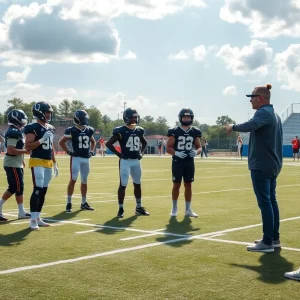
[167,126,202,159]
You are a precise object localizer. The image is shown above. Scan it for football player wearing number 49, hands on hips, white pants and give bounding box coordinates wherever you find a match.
[106,108,150,218]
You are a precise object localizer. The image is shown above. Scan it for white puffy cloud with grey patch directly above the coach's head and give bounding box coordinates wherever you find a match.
[216,40,273,76]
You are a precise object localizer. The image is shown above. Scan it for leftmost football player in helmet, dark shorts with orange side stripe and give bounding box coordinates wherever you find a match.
[0,109,30,222]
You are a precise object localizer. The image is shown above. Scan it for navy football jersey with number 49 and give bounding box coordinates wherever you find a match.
[113,125,145,159]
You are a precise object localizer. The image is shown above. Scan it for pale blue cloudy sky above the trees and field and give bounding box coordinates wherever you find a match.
[0,0,300,126]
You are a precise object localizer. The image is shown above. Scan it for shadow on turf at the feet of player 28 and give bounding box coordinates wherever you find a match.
[156,217,200,247]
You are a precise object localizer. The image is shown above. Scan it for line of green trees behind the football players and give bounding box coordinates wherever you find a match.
[0,98,236,139]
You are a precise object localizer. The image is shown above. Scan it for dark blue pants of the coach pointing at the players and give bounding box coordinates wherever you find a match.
[251,170,279,245]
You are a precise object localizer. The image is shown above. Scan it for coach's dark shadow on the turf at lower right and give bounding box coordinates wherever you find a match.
[231,249,294,284]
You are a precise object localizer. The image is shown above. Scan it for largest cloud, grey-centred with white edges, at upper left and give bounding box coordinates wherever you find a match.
[0,0,120,66]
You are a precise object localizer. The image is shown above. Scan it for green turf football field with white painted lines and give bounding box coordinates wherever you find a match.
[0,157,300,300]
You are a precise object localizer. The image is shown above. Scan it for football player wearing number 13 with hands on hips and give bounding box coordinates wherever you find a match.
[59,110,96,213]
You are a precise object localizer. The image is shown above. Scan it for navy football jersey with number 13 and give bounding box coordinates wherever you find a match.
[65,126,94,158]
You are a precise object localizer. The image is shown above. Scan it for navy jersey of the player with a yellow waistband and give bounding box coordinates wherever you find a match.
[24,123,55,160]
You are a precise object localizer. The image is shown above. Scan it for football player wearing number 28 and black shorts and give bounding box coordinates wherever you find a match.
[167,108,202,218]
